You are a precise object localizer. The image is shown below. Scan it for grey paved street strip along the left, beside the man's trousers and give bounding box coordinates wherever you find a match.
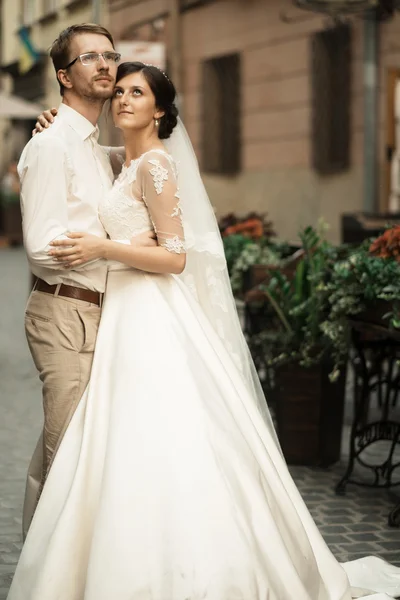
[0,248,41,600]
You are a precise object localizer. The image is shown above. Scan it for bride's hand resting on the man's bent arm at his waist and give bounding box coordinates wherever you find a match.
[48,232,107,269]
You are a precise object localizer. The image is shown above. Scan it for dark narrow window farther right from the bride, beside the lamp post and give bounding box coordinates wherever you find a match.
[311,25,351,174]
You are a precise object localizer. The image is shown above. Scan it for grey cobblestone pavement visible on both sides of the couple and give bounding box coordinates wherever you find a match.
[0,249,400,600]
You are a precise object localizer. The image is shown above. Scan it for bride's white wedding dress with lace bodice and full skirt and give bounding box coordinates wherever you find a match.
[8,151,400,600]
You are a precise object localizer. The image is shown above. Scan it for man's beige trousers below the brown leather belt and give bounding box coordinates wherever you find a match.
[22,291,101,539]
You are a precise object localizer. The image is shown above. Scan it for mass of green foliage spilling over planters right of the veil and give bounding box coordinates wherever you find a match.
[224,227,400,380]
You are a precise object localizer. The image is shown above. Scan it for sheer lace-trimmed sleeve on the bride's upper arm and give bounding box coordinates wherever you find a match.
[138,152,185,254]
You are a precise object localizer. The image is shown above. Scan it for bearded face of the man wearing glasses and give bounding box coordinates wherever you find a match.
[60,33,117,101]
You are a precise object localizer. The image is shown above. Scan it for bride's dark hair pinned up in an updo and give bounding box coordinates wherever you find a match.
[116,62,178,140]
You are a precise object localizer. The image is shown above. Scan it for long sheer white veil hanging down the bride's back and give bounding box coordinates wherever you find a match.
[165,119,279,446]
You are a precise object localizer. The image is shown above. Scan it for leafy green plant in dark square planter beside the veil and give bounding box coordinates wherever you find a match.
[242,227,347,466]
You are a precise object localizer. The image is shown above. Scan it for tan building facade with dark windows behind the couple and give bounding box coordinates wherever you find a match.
[110,0,400,241]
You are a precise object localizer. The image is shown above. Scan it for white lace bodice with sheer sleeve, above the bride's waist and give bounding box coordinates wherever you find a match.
[99,150,185,253]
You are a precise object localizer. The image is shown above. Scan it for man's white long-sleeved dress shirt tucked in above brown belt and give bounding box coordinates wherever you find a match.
[18,104,113,292]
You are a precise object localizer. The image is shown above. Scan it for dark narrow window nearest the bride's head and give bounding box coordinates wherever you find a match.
[202,54,241,175]
